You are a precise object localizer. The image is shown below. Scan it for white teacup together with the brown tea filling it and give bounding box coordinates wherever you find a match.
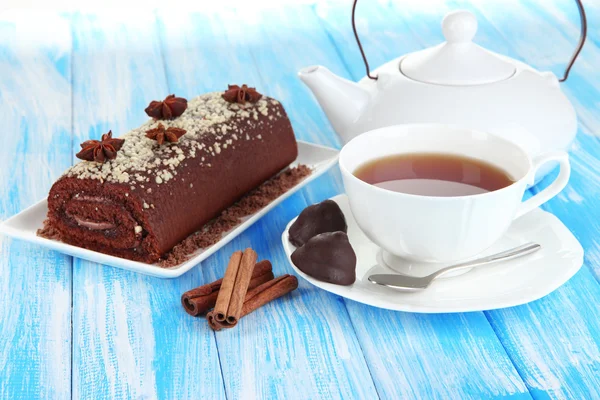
[340,124,570,262]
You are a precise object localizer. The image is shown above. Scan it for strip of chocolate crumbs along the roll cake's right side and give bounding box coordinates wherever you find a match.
[158,165,311,268]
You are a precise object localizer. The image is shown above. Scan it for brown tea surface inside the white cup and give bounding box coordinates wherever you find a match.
[354,153,514,197]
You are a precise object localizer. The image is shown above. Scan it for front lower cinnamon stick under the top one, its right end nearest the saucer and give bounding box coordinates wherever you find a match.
[206,275,298,331]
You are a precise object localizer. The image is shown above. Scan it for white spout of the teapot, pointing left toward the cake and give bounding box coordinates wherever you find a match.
[298,66,370,142]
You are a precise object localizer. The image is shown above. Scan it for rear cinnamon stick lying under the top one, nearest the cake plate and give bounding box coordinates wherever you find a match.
[181,260,273,317]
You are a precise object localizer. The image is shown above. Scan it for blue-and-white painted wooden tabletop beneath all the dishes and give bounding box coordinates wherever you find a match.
[0,0,600,399]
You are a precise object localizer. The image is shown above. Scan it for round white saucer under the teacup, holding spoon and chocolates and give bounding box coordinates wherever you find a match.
[282,194,583,313]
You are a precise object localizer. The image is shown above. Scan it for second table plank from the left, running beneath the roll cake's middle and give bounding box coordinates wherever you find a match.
[73,11,225,399]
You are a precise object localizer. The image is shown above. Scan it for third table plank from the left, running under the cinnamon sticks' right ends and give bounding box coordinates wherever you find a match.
[160,9,377,399]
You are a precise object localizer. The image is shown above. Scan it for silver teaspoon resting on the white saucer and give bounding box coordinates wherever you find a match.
[369,243,542,291]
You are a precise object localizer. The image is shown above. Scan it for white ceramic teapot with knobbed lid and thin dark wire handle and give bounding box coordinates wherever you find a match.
[299,6,586,178]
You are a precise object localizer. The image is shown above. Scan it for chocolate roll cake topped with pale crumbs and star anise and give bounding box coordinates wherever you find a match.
[46,86,298,263]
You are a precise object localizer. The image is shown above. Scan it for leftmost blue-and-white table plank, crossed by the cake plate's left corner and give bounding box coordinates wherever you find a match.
[0,11,71,399]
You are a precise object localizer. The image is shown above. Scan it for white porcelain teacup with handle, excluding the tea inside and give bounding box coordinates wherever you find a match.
[340,124,571,262]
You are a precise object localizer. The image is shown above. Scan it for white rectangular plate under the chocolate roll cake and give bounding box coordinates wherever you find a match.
[0,141,339,278]
